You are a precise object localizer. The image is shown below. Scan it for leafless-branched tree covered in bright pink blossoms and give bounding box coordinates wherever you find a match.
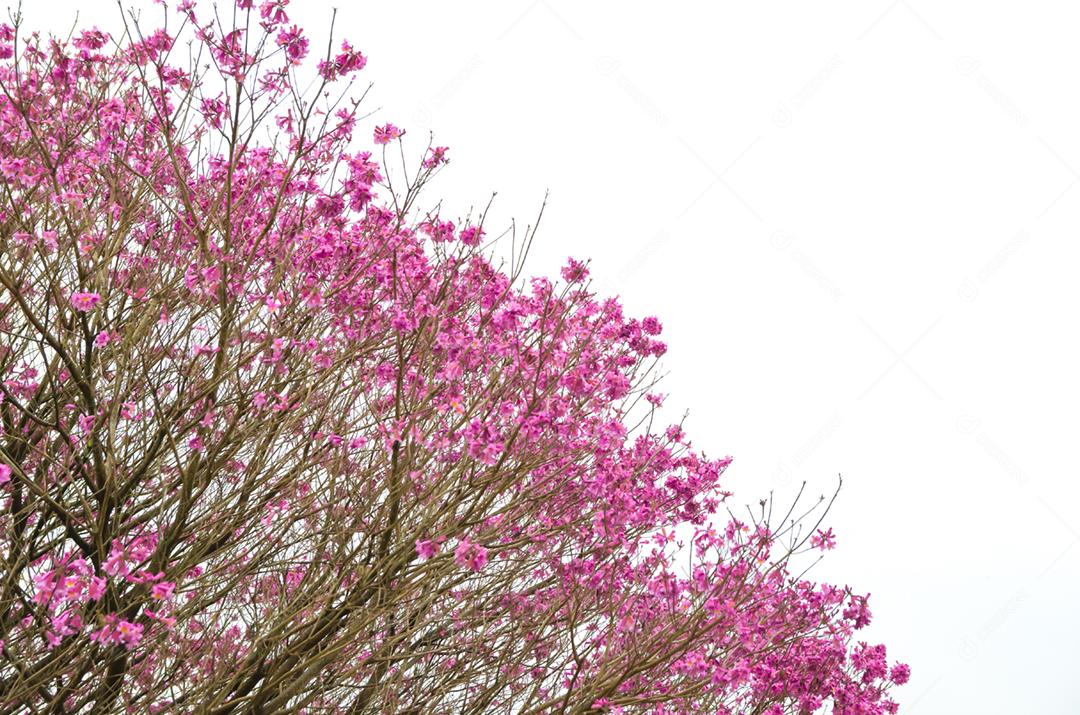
[0,0,908,715]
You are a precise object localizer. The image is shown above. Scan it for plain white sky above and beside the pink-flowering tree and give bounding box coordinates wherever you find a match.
[19,0,1080,715]
